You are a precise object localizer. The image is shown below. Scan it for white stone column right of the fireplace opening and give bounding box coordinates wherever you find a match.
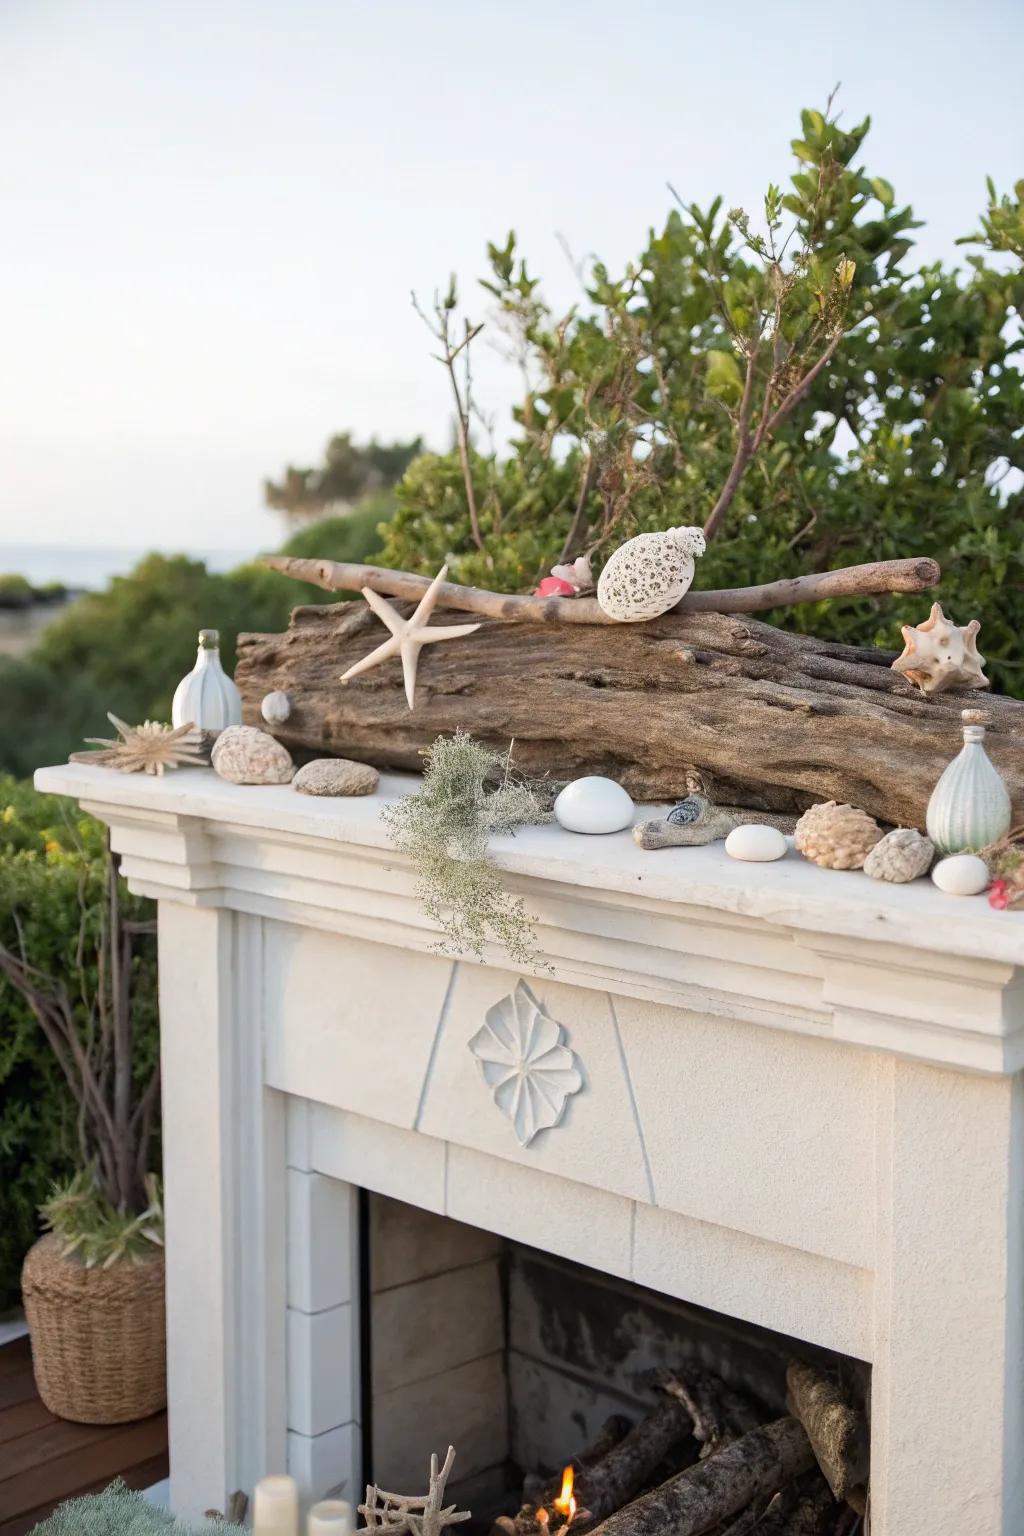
[870,1057,1024,1536]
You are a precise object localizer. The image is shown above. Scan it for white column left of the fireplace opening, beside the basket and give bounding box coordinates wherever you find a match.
[158,900,286,1519]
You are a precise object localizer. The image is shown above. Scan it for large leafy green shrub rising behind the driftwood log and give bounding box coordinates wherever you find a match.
[381,112,1024,694]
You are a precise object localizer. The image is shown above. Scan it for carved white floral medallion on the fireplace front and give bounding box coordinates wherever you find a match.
[470,980,583,1147]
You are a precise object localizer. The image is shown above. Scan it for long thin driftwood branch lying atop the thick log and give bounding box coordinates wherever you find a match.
[263,554,941,625]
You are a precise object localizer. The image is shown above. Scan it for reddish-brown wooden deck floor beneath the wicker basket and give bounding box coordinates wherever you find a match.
[0,1338,167,1536]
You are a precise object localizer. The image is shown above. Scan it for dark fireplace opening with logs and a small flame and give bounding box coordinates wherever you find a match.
[362,1193,870,1536]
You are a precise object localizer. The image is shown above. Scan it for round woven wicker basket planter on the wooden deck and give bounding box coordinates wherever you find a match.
[21,1236,167,1424]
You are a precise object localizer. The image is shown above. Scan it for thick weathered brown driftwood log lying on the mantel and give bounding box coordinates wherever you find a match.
[235,602,1024,826]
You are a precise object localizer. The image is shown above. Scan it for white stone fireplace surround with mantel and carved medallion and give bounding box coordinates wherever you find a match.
[37,765,1024,1536]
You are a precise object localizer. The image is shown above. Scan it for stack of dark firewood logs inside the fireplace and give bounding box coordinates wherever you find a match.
[491,1361,869,1536]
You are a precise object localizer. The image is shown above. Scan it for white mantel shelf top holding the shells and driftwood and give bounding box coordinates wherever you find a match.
[35,763,1024,965]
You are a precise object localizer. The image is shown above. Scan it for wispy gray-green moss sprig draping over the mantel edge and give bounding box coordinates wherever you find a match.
[381,731,556,966]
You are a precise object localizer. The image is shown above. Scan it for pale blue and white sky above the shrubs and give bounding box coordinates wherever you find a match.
[0,0,1024,550]
